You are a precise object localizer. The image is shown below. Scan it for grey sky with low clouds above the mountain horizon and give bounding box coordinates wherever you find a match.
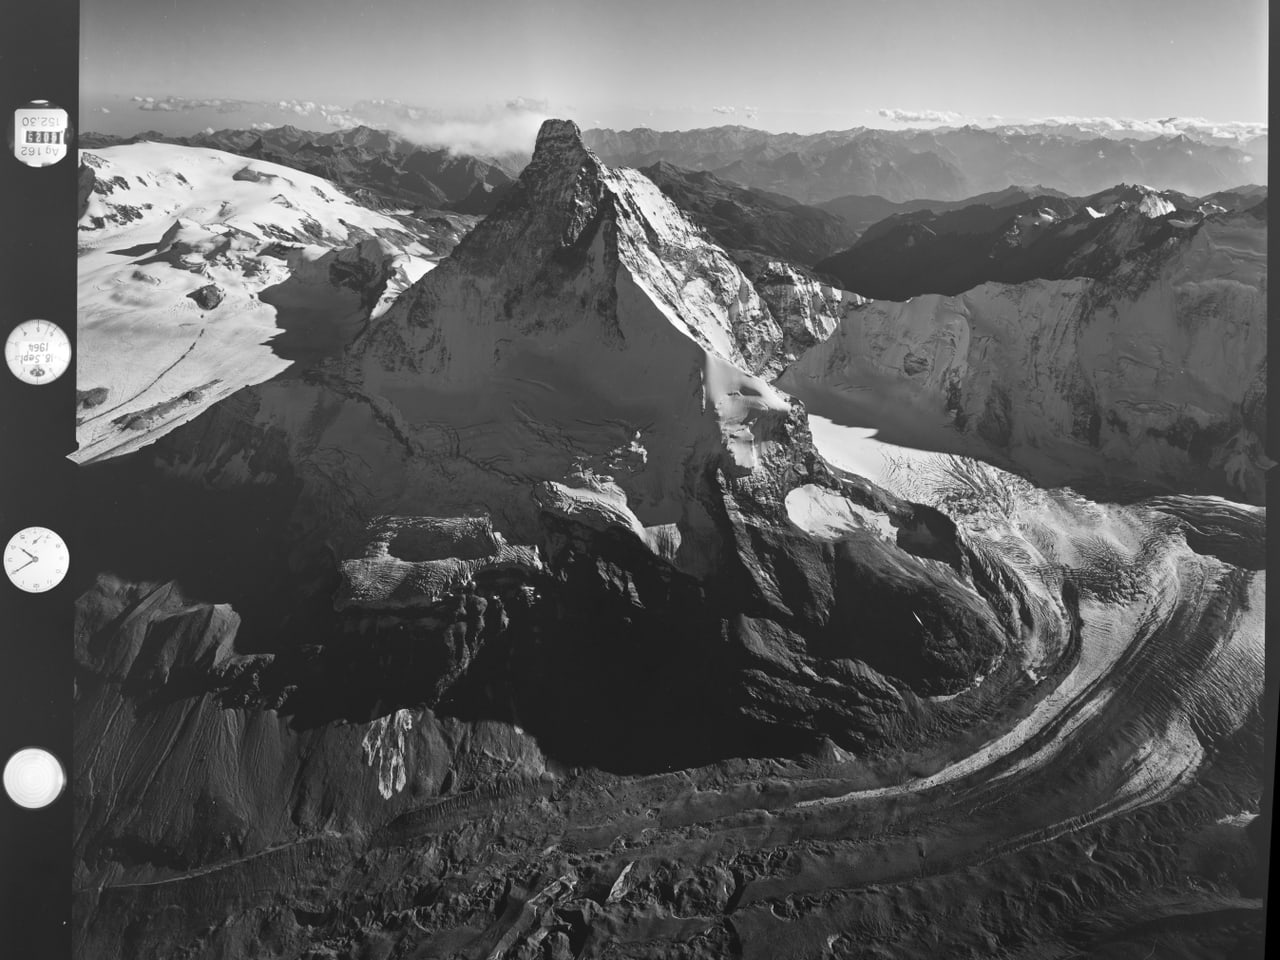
[81,0,1267,147]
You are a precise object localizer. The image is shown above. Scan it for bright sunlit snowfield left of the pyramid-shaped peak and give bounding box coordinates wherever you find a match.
[73,143,438,462]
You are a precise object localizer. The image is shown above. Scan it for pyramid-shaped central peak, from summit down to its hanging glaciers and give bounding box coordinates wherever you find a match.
[349,120,791,542]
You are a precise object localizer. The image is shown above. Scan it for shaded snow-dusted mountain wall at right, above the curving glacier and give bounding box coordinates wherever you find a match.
[778,209,1270,502]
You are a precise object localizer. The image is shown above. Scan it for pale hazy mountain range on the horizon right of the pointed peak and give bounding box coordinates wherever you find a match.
[582,127,1266,204]
